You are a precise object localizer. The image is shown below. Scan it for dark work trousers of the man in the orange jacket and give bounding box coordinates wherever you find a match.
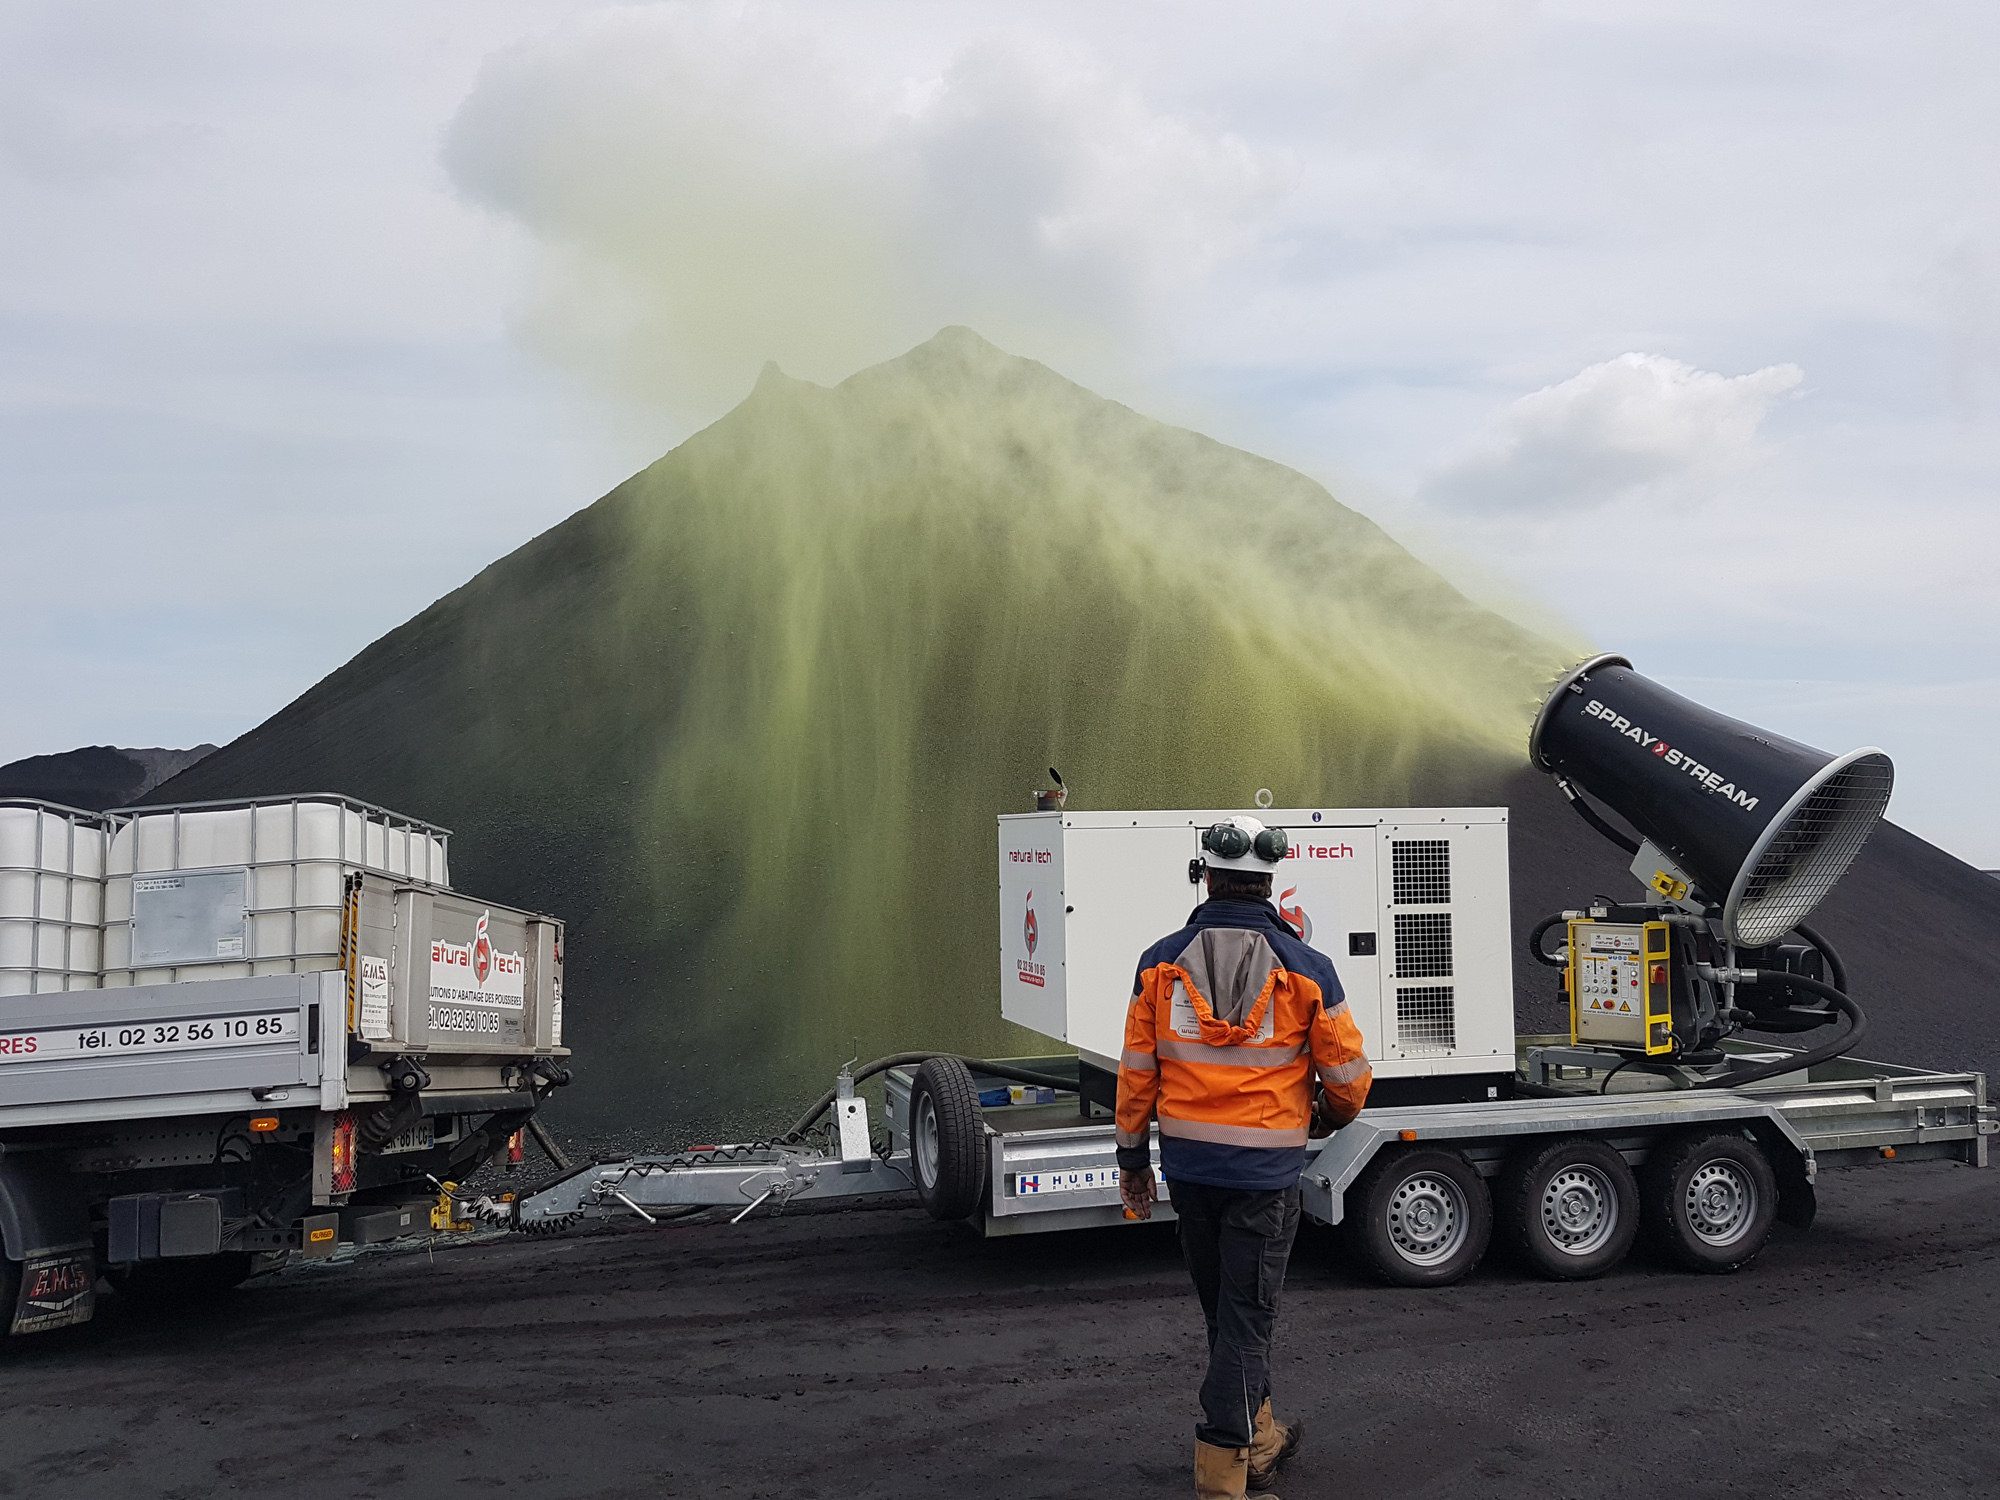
[1166,1182,1298,1448]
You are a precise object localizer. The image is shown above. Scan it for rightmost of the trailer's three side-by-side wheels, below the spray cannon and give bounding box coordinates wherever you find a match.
[1644,1132,1778,1274]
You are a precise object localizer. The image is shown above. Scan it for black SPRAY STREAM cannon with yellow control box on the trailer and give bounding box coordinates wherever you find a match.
[1528,654,1896,1088]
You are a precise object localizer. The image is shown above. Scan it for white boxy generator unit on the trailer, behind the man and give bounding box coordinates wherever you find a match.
[1000,808,1514,1098]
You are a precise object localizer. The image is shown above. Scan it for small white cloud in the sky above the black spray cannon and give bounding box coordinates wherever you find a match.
[1424,354,1806,510]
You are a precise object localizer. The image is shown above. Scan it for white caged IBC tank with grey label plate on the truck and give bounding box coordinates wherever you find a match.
[104,796,450,986]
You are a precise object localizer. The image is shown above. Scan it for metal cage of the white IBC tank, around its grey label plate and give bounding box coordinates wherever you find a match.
[104,792,452,984]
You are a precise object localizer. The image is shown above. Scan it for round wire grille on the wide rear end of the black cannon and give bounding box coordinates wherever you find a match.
[1732,754,1896,948]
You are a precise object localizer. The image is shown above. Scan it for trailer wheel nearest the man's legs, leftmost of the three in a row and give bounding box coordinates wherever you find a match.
[1342,1150,1494,1286]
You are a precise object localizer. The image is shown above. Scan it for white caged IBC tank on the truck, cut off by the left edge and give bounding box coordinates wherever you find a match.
[0,800,110,994]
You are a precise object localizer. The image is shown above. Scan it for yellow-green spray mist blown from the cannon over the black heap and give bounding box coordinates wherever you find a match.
[600,328,1560,1128]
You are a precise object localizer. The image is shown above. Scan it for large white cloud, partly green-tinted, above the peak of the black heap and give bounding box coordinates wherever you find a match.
[446,6,1288,416]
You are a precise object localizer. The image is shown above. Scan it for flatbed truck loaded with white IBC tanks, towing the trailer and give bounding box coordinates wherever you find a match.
[0,794,568,1334]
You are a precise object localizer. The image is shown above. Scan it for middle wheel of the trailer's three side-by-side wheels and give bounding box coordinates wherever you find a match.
[1500,1136,1638,1282]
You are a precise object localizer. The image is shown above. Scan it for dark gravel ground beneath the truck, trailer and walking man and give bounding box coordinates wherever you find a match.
[0,1164,2000,1500]
